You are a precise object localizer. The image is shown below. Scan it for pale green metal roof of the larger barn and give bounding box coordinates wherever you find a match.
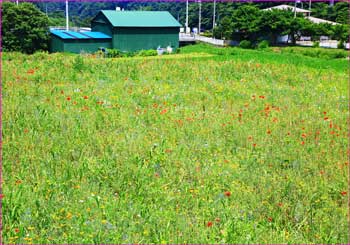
[101,10,181,27]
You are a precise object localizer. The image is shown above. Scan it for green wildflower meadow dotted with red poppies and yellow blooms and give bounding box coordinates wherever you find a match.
[2,45,349,244]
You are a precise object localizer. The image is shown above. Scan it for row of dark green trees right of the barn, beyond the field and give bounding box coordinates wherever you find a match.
[214,4,349,44]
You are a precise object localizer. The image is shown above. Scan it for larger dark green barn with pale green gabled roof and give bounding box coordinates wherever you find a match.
[91,10,181,51]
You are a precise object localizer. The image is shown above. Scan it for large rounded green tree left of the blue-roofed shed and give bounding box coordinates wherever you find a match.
[2,2,49,54]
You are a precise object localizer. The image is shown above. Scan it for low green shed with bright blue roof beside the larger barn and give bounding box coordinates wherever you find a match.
[50,30,112,53]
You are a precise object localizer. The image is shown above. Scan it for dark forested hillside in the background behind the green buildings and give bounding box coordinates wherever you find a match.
[35,1,349,29]
